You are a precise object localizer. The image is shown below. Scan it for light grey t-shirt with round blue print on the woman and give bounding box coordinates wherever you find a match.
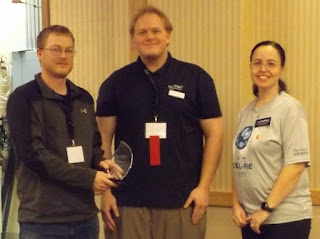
[233,91,312,224]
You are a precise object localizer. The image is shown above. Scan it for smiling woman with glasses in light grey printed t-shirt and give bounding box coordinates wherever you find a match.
[233,41,312,239]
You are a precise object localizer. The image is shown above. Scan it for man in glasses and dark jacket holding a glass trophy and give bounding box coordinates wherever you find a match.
[7,25,117,239]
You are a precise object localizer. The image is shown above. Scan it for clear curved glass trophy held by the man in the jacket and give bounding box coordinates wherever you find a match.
[109,141,133,183]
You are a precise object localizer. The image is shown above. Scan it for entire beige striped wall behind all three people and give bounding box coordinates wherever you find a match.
[18,0,320,238]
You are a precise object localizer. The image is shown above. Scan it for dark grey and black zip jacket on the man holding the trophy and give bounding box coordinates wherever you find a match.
[7,74,103,223]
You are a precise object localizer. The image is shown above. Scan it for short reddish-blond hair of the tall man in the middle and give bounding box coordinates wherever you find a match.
[129,5,173,36]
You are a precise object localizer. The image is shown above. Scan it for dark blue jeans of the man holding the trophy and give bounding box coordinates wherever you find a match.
[20,216,99,239]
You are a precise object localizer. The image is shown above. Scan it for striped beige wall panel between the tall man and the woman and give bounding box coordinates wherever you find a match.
[149,0,241,191]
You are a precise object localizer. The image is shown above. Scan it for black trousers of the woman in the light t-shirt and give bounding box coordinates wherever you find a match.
[241,219,311,239]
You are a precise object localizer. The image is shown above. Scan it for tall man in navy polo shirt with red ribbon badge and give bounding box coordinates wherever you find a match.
[97,6,223,239]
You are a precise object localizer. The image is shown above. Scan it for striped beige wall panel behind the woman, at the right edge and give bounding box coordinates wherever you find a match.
[246,0,320,190]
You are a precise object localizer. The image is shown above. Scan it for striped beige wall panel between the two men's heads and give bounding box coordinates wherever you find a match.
[50,0,130,99]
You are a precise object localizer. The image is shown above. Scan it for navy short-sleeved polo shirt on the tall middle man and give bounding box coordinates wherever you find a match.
[97,53,221,208]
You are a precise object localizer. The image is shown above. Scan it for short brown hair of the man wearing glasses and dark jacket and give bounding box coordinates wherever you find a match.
[37,25,75,49]
